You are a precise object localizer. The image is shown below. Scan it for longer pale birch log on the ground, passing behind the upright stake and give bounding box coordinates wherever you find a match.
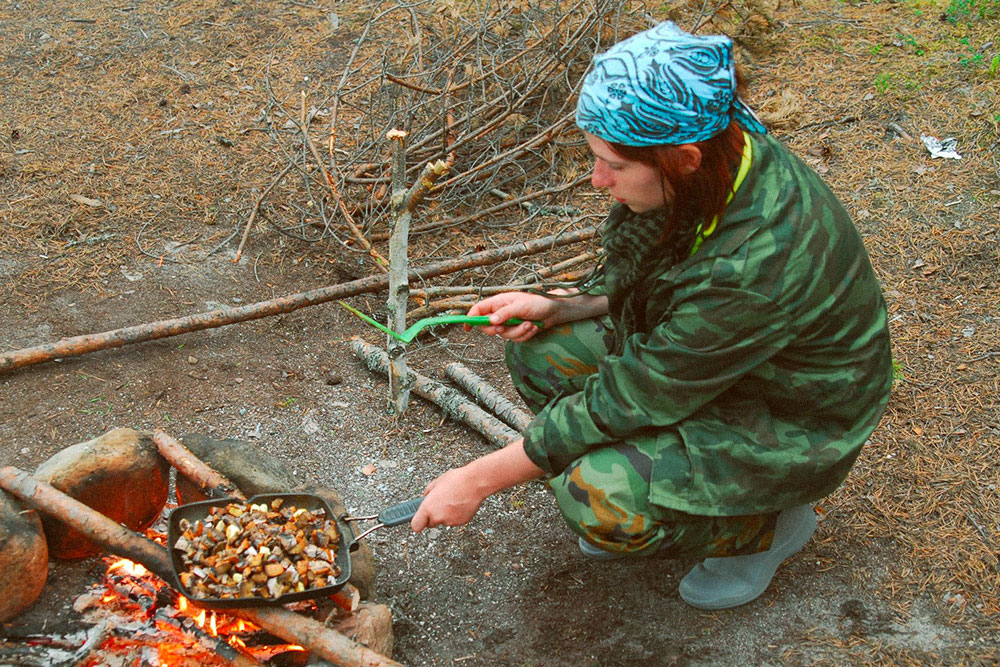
[351,338,517,447]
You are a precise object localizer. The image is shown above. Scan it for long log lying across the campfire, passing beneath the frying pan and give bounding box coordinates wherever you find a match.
[0,466,399,667]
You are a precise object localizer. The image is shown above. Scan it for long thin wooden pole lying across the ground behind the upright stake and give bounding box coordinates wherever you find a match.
[0,227,598,373]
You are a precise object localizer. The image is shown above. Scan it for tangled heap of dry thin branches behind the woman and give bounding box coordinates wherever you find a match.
[246,0,648,270]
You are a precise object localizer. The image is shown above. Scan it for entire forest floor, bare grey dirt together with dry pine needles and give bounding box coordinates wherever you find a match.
[0,0,1000,666]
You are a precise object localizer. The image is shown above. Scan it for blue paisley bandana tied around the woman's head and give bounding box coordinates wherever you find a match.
[576,21,767,146]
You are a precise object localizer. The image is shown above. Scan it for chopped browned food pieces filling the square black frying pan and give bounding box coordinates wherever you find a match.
[172,498,340,599]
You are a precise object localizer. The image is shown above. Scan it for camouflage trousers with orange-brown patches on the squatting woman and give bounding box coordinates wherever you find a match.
[507,320,778,558]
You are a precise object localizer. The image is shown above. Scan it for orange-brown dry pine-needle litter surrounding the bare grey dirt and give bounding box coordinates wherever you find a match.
[0,0,1000,663]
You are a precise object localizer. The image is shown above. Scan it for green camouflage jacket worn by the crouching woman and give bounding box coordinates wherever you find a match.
[524,135,892,515]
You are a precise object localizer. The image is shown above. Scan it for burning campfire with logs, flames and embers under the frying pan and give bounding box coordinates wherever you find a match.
[0,432,397,667]
